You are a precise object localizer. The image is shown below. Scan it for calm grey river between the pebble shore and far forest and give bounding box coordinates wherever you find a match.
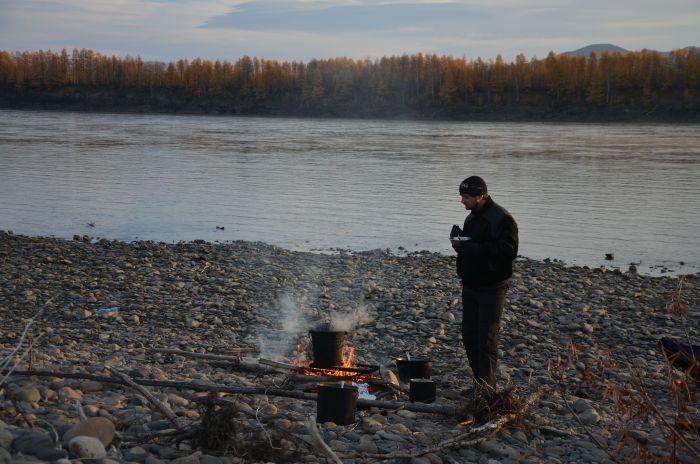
[0,110,700,274]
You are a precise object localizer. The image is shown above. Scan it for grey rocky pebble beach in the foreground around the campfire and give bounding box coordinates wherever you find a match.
[0,231,700,464]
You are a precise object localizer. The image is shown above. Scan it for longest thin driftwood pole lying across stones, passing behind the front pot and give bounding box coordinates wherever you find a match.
[12,370,455,416]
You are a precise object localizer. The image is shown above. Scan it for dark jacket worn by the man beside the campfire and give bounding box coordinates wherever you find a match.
[457,197,518,289]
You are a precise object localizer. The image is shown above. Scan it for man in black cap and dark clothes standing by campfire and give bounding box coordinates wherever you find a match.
[450,176,518,387]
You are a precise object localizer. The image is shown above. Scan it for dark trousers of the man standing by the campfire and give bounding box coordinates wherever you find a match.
[462,282,508,387]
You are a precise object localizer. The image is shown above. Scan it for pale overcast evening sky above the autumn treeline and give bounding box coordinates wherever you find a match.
[0,0,700,61]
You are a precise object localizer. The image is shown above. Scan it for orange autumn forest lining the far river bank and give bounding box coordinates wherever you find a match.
[0,49,700,121]
